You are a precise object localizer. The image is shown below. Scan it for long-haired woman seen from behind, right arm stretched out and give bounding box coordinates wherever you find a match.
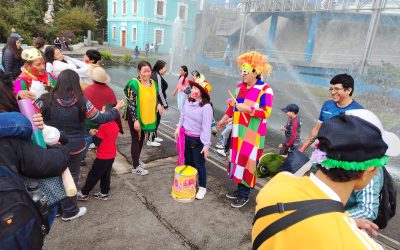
[35,69,124,221]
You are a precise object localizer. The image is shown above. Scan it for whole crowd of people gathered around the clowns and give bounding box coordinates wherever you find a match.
[0,28,400,249]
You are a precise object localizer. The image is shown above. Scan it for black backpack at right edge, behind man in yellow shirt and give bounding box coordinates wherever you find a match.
[374,167,397,229]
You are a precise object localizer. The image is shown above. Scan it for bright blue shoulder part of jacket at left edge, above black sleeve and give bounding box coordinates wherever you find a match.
[0,112,32,140]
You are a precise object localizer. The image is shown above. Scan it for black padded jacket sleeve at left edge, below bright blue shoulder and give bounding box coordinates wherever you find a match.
[0,137,69,178]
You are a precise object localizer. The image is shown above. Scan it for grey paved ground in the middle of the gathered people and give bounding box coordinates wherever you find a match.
[44,110,393,249]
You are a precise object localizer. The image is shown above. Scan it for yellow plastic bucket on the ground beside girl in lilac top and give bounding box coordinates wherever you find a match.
[171,165,197,203]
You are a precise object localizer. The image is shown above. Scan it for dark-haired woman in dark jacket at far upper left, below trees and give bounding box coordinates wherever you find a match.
[2,36,24,80]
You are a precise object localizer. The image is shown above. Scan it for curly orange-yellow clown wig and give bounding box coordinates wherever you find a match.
[236,51,272,76]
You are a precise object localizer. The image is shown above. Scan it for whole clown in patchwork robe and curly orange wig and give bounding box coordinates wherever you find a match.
[217,51,273,207]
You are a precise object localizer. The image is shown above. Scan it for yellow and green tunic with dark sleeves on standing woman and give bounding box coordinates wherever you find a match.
[123,78,158,132]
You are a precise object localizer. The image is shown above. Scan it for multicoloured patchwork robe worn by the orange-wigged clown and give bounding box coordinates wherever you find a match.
[225,80,273,187]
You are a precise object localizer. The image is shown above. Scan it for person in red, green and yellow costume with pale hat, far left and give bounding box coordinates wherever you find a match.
[14,48,57,99]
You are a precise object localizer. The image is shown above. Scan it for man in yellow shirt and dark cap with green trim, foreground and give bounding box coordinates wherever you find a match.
[252,109,400,250]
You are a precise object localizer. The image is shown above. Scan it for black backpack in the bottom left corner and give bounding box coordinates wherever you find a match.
[0,163,48,250]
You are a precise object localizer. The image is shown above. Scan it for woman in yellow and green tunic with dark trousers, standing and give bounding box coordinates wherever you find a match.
[123,61,163,175]
